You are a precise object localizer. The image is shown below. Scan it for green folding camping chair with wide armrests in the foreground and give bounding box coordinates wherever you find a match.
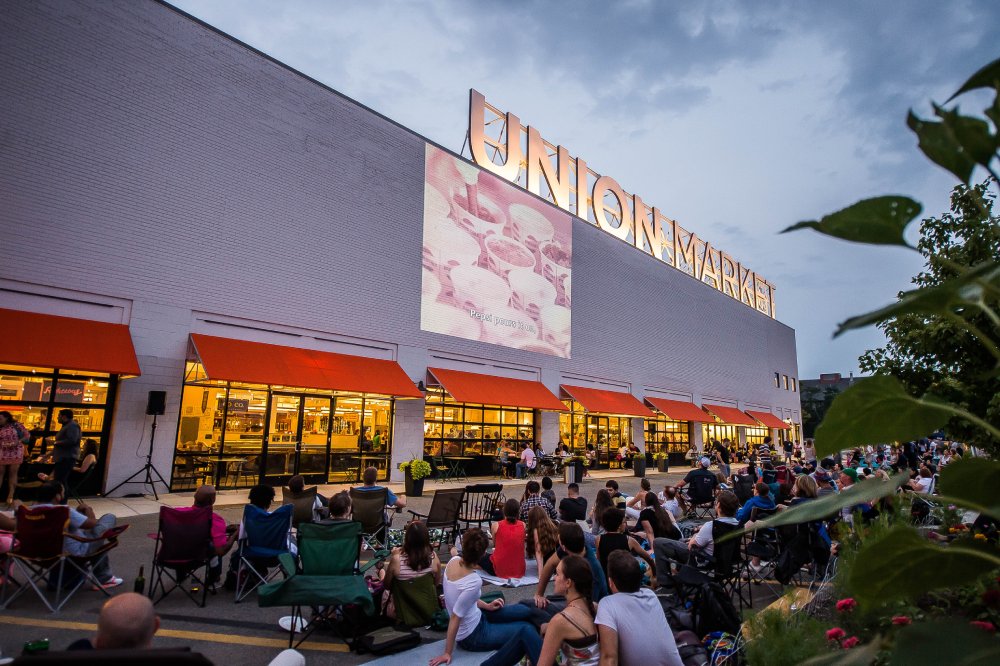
[257,521,389,648]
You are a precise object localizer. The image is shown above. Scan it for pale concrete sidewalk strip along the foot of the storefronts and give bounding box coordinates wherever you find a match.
[83,467,688,518]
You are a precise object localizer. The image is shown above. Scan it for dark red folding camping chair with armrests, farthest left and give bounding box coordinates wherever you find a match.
[0,506,128,613]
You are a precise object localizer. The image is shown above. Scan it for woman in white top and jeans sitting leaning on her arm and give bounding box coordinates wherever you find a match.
[429,527,542,666]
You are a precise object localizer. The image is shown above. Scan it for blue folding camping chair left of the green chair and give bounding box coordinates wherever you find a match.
[236,504,295,603]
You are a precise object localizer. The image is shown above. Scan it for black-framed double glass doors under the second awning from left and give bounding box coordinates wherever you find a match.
[262,393,330,485]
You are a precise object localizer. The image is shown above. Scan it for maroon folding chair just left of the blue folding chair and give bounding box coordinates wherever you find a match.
[149,506,215,608]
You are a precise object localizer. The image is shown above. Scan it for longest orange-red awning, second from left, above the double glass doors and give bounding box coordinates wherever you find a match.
[191,333,423,398]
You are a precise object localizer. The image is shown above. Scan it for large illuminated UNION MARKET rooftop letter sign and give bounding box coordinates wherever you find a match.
[469,90,775,318]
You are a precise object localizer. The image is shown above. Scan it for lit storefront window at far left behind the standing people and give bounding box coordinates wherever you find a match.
[0,365,118,494]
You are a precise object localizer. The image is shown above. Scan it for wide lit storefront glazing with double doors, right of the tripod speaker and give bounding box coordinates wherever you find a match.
[171,362,394,490]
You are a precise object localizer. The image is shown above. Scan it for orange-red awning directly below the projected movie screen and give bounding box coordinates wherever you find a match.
[427,368,567,412]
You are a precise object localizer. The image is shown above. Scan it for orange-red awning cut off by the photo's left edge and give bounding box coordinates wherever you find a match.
[0,309,139,376]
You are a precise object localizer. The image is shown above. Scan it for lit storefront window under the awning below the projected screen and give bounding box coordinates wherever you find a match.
[424,387,535,474]
